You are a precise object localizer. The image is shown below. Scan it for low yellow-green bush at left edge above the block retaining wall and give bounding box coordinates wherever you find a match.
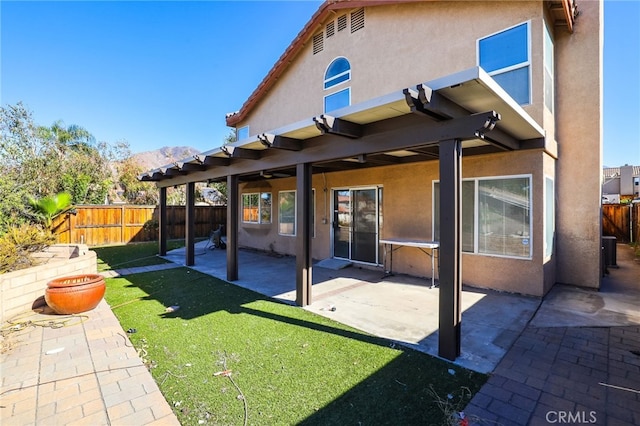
[0,224,55,274]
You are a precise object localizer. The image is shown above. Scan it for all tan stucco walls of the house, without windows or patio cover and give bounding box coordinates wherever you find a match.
[228,1,602,296]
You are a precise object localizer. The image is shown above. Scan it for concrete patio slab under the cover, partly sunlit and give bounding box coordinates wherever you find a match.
[166,242,541,373]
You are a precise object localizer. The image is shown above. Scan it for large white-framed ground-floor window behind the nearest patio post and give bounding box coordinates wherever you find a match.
[433,176,532,258]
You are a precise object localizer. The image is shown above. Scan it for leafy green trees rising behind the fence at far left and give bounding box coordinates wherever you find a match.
[0,102,122,210]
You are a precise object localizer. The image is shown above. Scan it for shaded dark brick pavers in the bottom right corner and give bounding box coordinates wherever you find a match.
[465,326,640,425]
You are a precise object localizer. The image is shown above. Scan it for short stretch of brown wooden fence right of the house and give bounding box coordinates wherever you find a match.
[602,203,640,243]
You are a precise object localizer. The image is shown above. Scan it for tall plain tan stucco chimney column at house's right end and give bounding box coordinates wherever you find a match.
[556,1,603,288]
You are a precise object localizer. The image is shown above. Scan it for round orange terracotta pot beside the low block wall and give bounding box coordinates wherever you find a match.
[44,274,105,314]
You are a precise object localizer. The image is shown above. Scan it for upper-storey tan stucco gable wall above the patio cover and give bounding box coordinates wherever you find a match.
[237,1,544,135]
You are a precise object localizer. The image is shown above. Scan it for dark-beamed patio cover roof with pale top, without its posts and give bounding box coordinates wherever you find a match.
[139,67,544,187]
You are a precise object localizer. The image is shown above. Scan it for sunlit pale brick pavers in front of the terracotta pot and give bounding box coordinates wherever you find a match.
[0,300,179,426]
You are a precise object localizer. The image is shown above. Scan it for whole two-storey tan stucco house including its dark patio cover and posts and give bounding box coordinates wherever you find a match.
[140,0,603,359]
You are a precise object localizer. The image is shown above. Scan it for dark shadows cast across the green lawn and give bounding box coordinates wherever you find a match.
[116,268,484,425]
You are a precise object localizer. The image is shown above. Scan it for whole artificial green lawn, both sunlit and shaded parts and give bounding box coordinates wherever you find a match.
[105,268,486,425]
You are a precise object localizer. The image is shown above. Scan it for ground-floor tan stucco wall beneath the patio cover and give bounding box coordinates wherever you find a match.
[239,151,553,296]
